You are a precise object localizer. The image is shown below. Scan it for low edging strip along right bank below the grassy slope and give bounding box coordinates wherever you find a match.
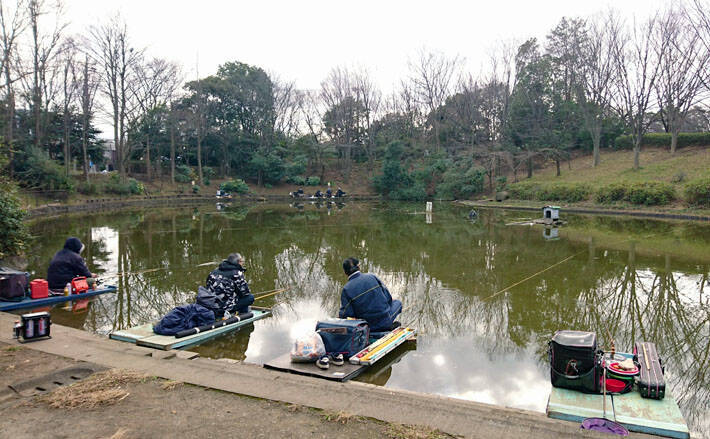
[454,200,710,221]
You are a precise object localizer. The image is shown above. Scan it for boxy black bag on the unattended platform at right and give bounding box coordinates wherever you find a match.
[548,331,601,393]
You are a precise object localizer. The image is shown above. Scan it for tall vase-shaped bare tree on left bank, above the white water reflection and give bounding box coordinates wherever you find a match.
[90,16,143,178]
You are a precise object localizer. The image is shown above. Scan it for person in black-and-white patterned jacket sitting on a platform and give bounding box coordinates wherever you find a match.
[206,253,254,319]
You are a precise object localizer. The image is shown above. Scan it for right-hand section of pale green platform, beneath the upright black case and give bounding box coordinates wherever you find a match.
[613,390,690,439]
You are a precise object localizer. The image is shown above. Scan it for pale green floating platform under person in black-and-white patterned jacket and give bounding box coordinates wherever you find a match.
[109,306,271,351]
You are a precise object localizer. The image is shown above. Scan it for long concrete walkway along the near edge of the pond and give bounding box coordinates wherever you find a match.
[0,313,651,439]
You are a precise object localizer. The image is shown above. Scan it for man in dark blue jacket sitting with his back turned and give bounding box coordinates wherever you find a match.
[338,258,402,332]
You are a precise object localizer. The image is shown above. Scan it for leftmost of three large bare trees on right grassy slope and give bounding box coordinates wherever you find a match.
[576,13,621,167]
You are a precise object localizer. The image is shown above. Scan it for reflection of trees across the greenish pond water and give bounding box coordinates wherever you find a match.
[30,205,710,434]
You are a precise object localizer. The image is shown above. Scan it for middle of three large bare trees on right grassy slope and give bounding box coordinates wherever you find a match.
[612,16,666,169]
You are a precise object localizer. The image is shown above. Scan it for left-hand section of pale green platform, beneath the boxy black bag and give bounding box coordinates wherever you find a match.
[547,387,614,424]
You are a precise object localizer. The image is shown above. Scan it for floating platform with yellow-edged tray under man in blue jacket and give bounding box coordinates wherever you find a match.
[264,328,416,382]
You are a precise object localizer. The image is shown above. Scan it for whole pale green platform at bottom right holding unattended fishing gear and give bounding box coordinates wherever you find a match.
[547,387,690,439]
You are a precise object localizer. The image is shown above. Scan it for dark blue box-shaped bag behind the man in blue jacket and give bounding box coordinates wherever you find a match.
[316,319,370,359]
